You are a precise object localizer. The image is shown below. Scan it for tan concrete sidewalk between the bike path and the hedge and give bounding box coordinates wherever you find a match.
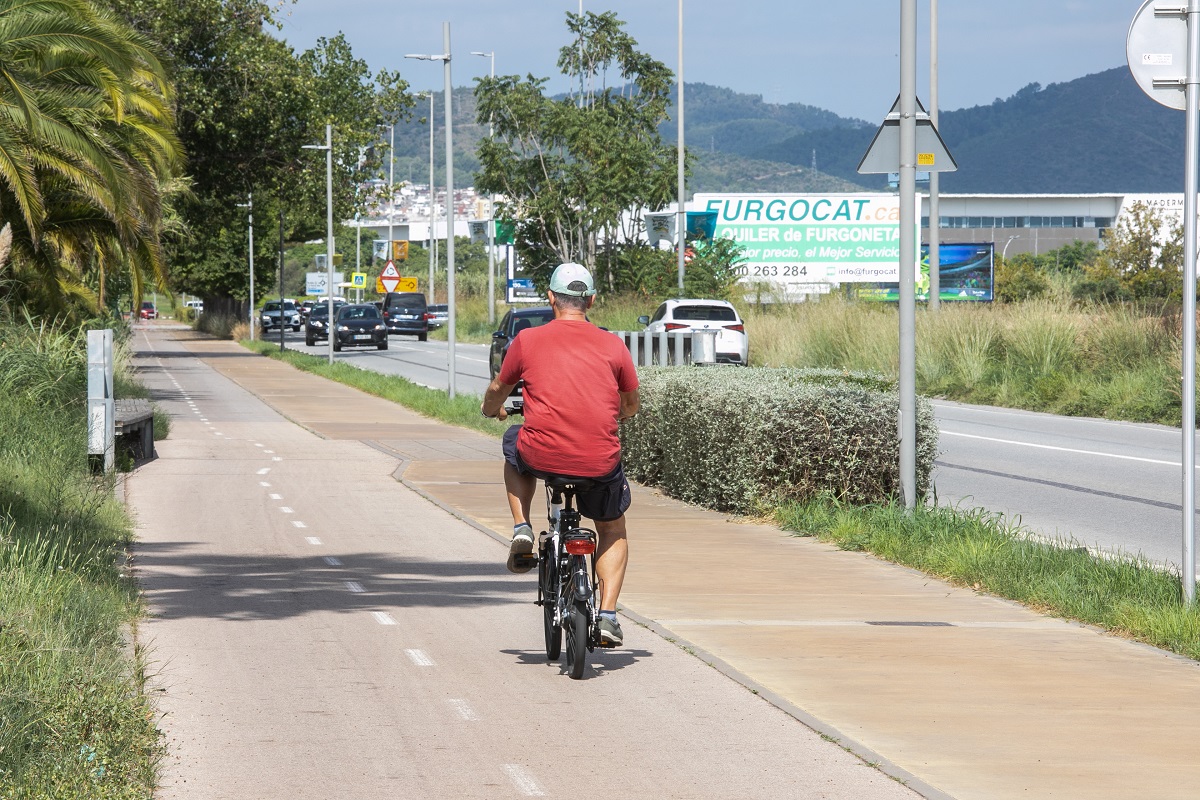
[174,338,1200,800]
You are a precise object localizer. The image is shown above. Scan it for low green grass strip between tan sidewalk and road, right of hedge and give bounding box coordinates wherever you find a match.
[775,499,1200,660]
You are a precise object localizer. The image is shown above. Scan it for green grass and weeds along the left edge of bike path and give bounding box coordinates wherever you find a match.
[0,319,160,800]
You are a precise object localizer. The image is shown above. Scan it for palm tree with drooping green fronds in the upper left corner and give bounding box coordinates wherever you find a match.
[0,0,181,319]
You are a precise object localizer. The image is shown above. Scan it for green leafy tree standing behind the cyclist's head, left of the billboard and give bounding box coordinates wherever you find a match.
[475,12,676,292]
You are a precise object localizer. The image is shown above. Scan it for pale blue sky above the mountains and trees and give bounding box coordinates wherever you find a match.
[280,0,1141,122]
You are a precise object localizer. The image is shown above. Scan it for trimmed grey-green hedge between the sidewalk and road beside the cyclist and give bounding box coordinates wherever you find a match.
[622,367,937,513]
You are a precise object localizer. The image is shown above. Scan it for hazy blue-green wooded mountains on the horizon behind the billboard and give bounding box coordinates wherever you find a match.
[396,66,1184,194]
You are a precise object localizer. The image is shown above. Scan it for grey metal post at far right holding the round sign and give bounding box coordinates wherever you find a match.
[1183,0,1200,604]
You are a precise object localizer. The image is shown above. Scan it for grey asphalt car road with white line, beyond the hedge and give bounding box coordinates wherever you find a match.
[265,332,1200,573]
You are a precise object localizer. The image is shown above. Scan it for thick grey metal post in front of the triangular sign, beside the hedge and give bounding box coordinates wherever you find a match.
[899,0,916,509]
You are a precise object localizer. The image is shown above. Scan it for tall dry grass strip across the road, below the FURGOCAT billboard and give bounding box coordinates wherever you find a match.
[743,293,1182,425]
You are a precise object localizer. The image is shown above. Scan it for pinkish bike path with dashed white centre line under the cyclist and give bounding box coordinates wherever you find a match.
[127,330,912,800]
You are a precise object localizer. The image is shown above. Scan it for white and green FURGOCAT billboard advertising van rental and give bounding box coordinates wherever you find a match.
[694,193,920,294]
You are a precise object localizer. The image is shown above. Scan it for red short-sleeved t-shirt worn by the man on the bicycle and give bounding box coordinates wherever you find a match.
[498,319,637,477]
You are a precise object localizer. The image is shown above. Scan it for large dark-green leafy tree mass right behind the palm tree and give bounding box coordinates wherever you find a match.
[99,0,412,303]
